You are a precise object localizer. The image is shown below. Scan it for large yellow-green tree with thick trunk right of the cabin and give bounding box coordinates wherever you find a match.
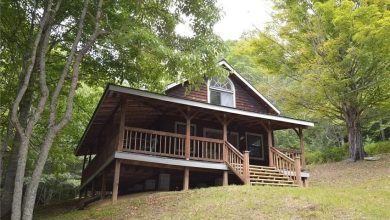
[245,0,390,161]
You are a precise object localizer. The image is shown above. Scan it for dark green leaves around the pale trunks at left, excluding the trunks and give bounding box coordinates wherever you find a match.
[0,0,223,207]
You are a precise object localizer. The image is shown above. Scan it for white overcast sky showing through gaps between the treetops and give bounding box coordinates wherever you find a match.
[176,0,272,40]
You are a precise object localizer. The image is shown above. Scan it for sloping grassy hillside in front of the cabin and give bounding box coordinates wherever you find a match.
[36,155,390,219]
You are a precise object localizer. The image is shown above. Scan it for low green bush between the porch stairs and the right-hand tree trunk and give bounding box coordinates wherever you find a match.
[305,146,348,164]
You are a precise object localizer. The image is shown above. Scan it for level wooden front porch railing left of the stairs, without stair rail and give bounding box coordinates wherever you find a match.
[123,127,224,162]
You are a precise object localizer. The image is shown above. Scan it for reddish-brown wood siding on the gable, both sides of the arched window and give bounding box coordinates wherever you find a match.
[166,74,272,114]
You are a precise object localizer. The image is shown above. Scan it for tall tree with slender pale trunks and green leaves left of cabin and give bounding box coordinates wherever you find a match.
[0,0,225,219]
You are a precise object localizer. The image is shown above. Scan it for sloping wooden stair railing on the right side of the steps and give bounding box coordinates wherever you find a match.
[270,147,301,185]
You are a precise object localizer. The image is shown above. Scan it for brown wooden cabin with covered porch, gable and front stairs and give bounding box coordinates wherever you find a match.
[76,60,314,202]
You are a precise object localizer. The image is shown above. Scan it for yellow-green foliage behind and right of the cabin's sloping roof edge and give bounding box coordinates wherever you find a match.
[230,0,390,158]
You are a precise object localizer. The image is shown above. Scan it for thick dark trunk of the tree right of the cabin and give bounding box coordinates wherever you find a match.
[344,106,365,161]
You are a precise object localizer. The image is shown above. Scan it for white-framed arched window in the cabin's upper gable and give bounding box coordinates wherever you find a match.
[208,78,235,107]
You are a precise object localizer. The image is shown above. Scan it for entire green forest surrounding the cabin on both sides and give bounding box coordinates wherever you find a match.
[0,0,390,219]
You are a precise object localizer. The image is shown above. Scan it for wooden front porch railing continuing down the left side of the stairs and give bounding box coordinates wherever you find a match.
[123,127,249,183]
